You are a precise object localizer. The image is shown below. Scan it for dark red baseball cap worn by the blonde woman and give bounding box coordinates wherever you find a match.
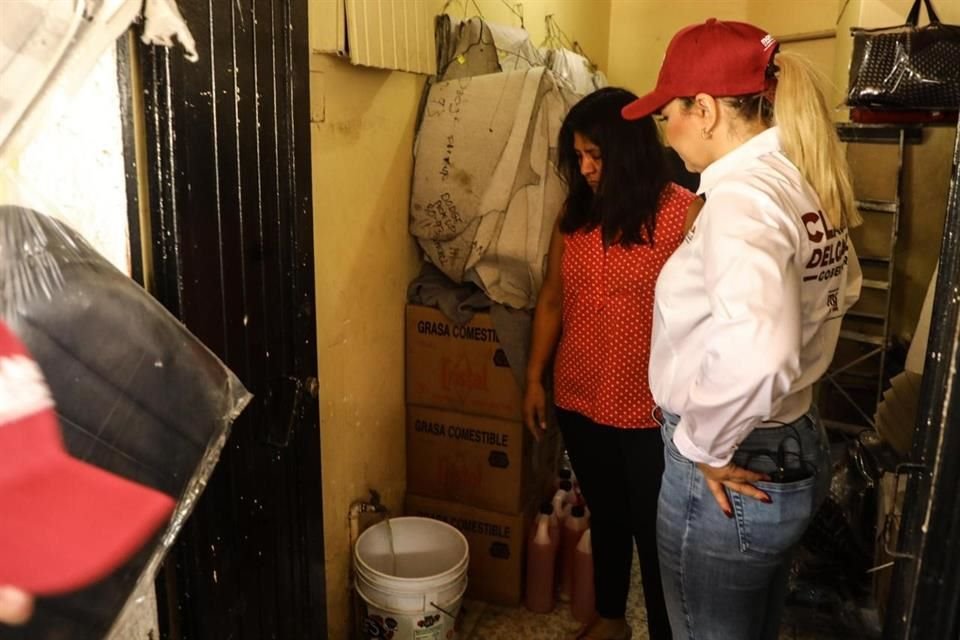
[621,18,778,120]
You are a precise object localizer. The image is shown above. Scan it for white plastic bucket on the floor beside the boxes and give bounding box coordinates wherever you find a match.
[353,517,470,640]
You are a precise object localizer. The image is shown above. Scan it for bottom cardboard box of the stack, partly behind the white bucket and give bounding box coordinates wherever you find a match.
[406,493,532,605]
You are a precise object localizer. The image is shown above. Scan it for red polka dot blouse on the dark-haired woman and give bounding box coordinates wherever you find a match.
[554,183,696,428]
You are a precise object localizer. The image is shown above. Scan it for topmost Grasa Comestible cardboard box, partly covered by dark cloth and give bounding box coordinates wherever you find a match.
[407,305,522,420]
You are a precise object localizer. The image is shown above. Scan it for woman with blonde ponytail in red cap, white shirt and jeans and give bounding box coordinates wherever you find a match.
[623,19,862,640]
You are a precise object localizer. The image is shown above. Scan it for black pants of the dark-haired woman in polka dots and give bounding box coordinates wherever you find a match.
[557,407,672,640]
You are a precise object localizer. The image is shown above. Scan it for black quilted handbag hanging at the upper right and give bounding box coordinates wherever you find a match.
[847,0,960,110]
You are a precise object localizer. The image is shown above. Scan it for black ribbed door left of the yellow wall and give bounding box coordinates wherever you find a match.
[140,0,326,640]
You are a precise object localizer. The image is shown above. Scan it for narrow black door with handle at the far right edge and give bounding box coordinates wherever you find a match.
[883,123,960,640]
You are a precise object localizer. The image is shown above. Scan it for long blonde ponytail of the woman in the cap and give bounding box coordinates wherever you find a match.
[773,52,863,229]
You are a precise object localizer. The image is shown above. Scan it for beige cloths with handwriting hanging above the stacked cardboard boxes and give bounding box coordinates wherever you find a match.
[422,15,606,308]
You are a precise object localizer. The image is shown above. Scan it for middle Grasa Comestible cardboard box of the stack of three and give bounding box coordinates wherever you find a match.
[407,405,560,513]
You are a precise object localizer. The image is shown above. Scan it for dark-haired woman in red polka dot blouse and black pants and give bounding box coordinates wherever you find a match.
[524,88,702,640]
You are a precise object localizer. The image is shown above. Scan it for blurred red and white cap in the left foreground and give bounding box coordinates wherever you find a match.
[0,323,174,596]
